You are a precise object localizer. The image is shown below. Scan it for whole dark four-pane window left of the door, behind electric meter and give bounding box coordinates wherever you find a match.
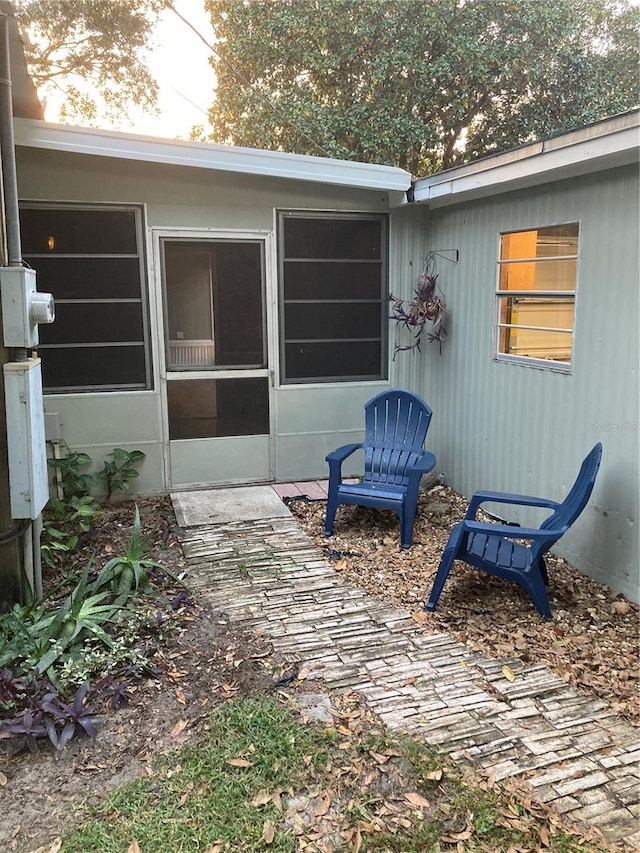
[20,204,151,393]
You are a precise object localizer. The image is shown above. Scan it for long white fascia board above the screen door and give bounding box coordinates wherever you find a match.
[14,119,411,191]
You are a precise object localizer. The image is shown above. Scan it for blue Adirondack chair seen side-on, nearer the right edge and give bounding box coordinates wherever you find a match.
[426,442,602,621]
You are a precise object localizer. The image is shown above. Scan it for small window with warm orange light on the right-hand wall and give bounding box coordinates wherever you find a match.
[496,223,579,369]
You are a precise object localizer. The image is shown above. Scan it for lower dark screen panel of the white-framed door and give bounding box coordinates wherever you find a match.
[167,377,269,441]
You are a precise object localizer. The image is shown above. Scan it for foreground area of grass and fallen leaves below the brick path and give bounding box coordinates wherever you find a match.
[61,696,615,853]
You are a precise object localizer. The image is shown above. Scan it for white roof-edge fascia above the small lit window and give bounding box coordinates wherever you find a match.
[414,118,640,207]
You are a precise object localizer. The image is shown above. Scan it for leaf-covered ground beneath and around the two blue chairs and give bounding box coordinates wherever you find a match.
[289,486,640,725]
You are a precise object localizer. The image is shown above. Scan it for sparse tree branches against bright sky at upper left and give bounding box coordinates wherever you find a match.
[14,0,165,123]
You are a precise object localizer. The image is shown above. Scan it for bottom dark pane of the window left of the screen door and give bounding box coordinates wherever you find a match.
[38,344,147,390]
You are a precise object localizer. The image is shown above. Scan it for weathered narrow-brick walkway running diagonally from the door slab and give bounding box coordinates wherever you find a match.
[175,506,640,849]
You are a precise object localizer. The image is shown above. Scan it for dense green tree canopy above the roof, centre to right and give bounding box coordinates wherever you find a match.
[205,0,638,173]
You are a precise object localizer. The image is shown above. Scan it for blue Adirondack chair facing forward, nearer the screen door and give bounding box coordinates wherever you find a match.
[325,389,436,548]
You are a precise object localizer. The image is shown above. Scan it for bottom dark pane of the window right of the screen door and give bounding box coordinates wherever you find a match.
[285,341,382,379]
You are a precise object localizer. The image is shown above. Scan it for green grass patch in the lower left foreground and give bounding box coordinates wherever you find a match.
[62,697,327,853]
